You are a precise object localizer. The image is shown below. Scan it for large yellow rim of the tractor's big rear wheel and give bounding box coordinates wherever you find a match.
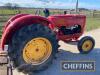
[23,37,52,65]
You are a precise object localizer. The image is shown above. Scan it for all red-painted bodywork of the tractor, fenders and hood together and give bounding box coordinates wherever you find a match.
[1,14,86,49]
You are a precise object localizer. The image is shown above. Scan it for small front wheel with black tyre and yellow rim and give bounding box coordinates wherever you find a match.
[78,36,95,54]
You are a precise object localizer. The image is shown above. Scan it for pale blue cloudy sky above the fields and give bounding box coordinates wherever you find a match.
[0,0,100,9]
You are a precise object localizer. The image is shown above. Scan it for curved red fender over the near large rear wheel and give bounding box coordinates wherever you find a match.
[1,15,54,49]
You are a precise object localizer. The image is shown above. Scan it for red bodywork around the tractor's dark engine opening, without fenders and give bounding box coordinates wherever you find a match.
[48,14,86,41]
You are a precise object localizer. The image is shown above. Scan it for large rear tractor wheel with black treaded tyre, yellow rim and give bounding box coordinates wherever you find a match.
[8,24,58,73]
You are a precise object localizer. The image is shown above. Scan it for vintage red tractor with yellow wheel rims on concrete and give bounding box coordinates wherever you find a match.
[1,14,95,72]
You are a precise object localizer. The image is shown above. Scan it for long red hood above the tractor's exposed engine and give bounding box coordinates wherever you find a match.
[48,14,86,26]
